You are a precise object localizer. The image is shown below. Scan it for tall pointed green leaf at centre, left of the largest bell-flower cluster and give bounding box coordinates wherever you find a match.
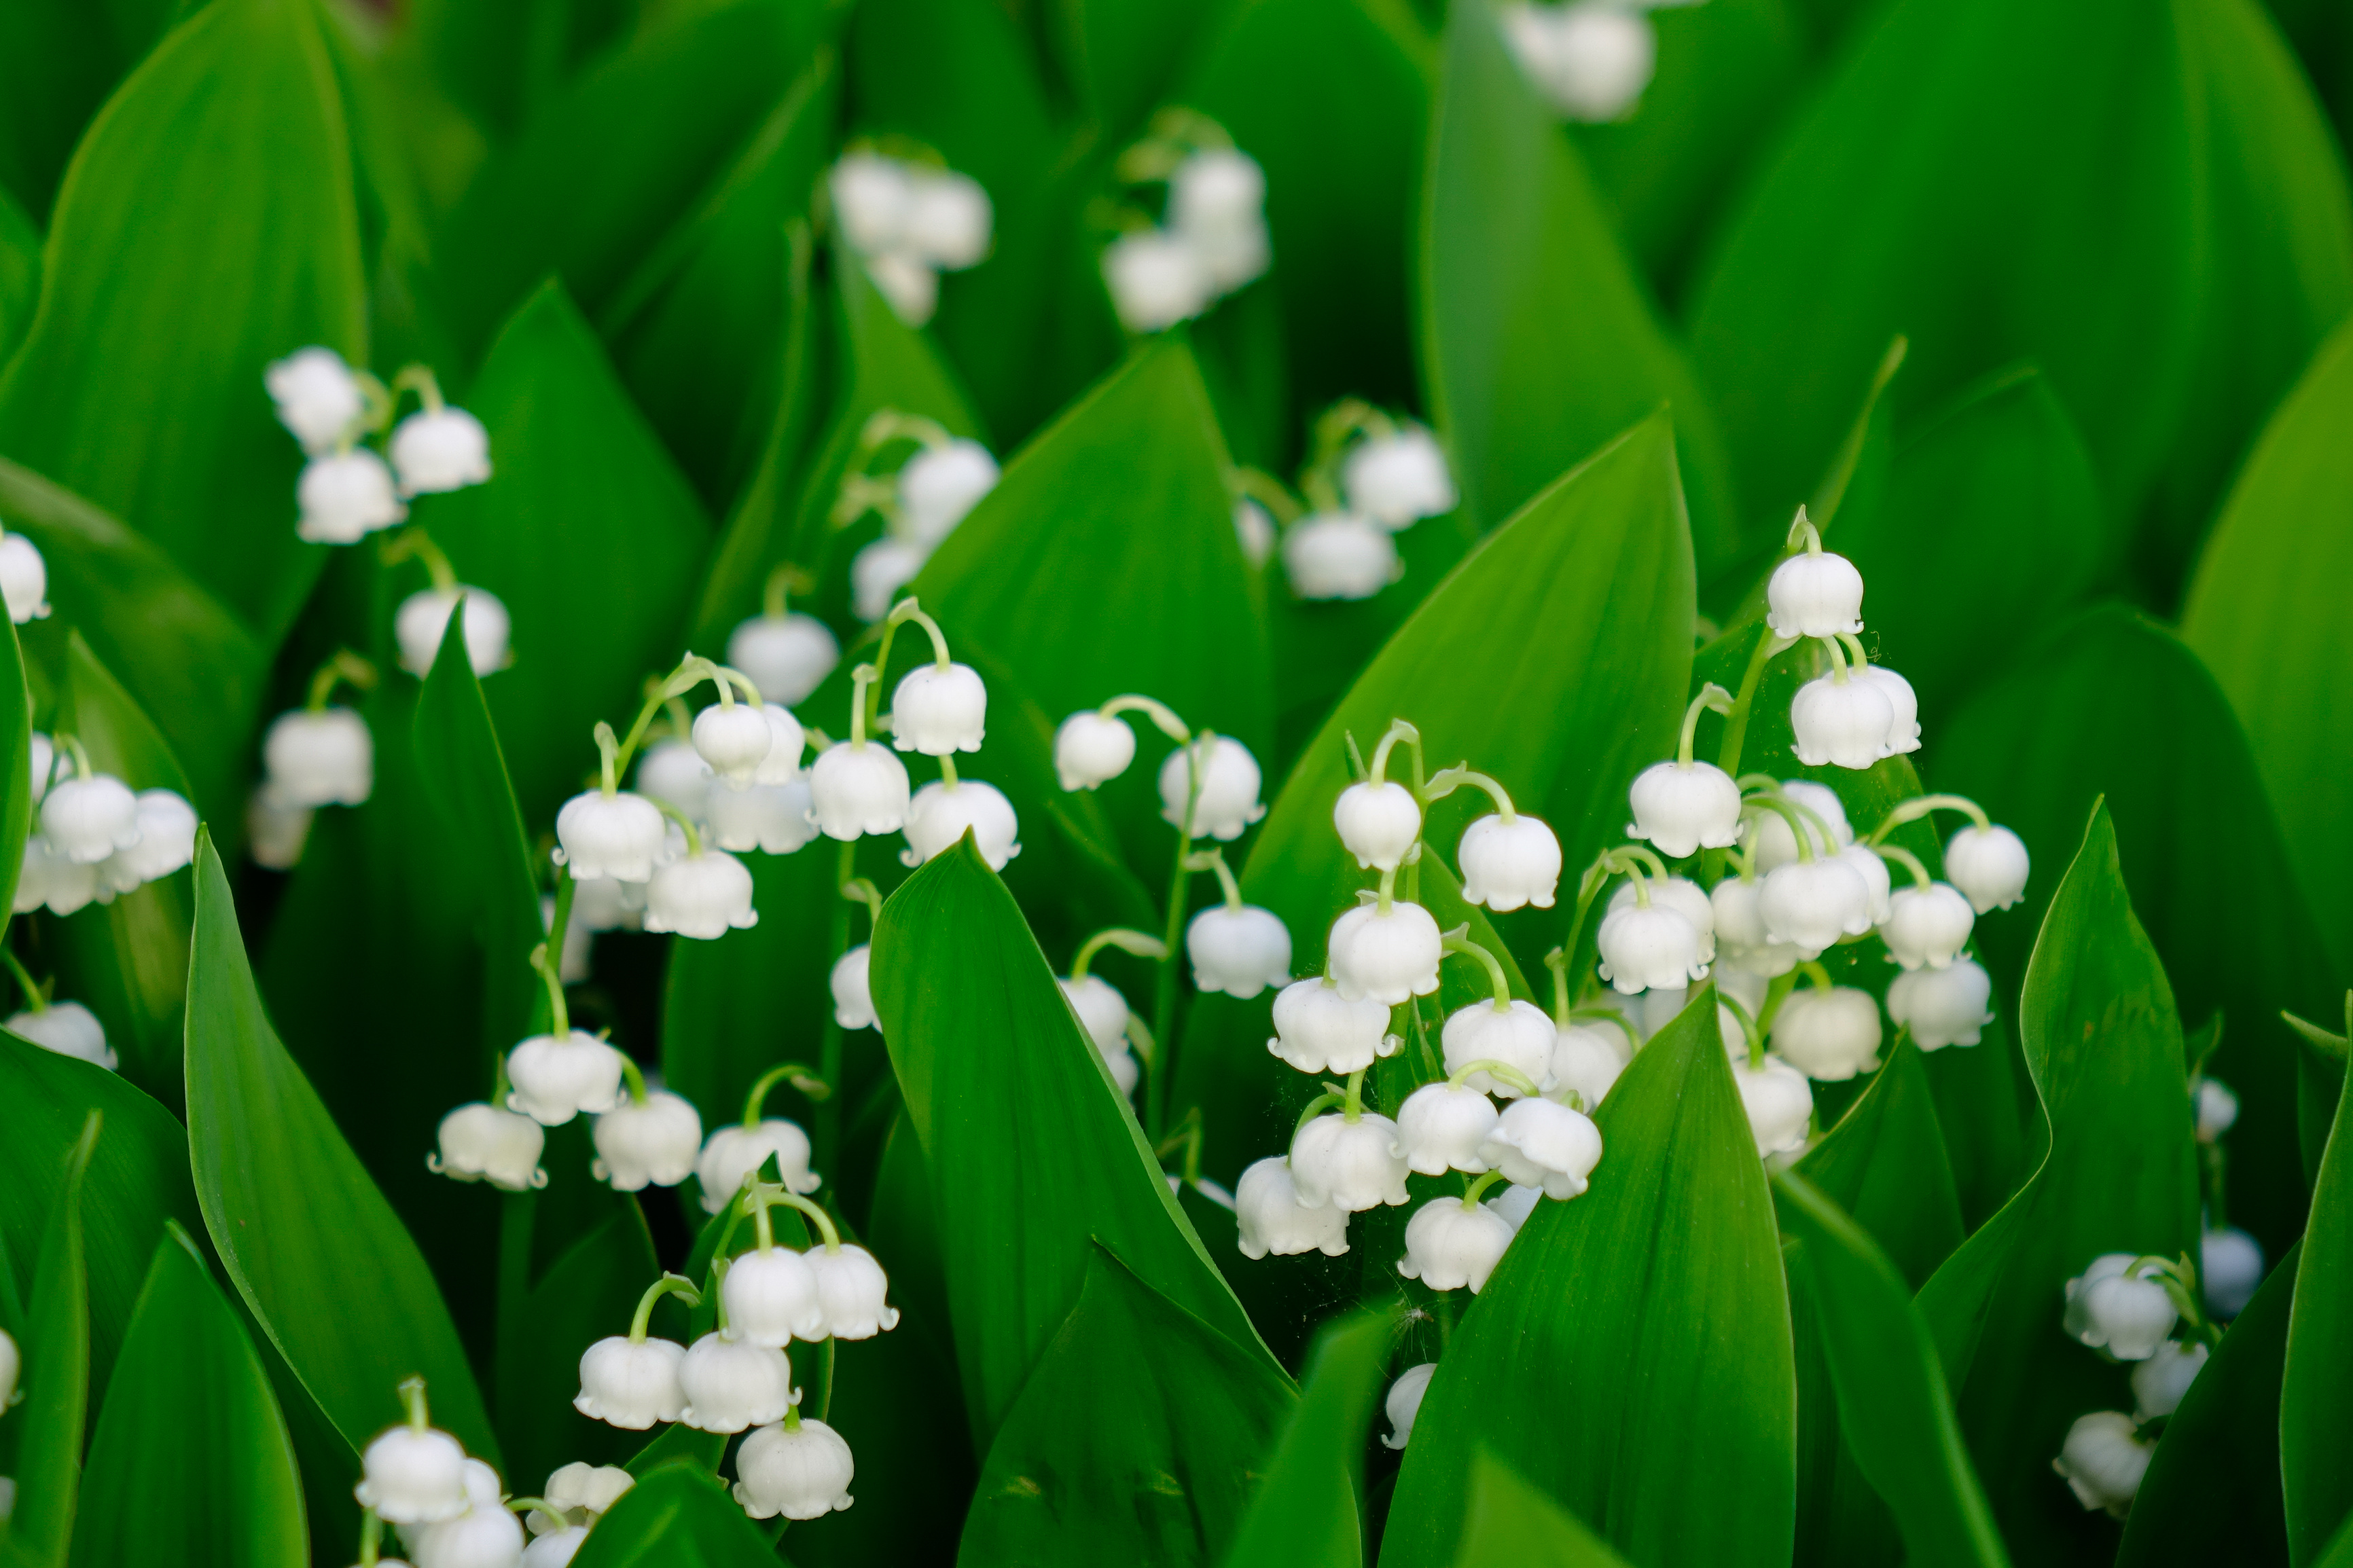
[873,837,1273,1448]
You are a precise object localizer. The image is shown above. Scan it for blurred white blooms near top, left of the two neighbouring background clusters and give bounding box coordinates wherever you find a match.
[826,146,993,327]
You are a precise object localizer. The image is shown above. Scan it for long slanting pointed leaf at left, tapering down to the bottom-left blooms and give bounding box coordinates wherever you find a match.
[188,832,499,1465]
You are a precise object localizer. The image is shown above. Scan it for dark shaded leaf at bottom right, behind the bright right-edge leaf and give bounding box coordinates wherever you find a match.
[2115,1246,2301,1568]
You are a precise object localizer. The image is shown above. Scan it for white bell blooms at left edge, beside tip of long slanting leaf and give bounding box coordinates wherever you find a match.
[16,731,196,915]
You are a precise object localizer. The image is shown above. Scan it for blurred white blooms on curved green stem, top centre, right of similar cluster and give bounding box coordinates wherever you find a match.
[1104,111,1273,334]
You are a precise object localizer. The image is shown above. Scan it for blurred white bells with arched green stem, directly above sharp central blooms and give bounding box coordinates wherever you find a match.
[833,409,998,625]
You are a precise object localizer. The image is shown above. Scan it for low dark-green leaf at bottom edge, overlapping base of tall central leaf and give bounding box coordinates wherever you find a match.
[955,1246,1289,1568]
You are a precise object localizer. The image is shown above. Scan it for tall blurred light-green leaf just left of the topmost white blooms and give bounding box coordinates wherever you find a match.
[1421,5,1750,571]
